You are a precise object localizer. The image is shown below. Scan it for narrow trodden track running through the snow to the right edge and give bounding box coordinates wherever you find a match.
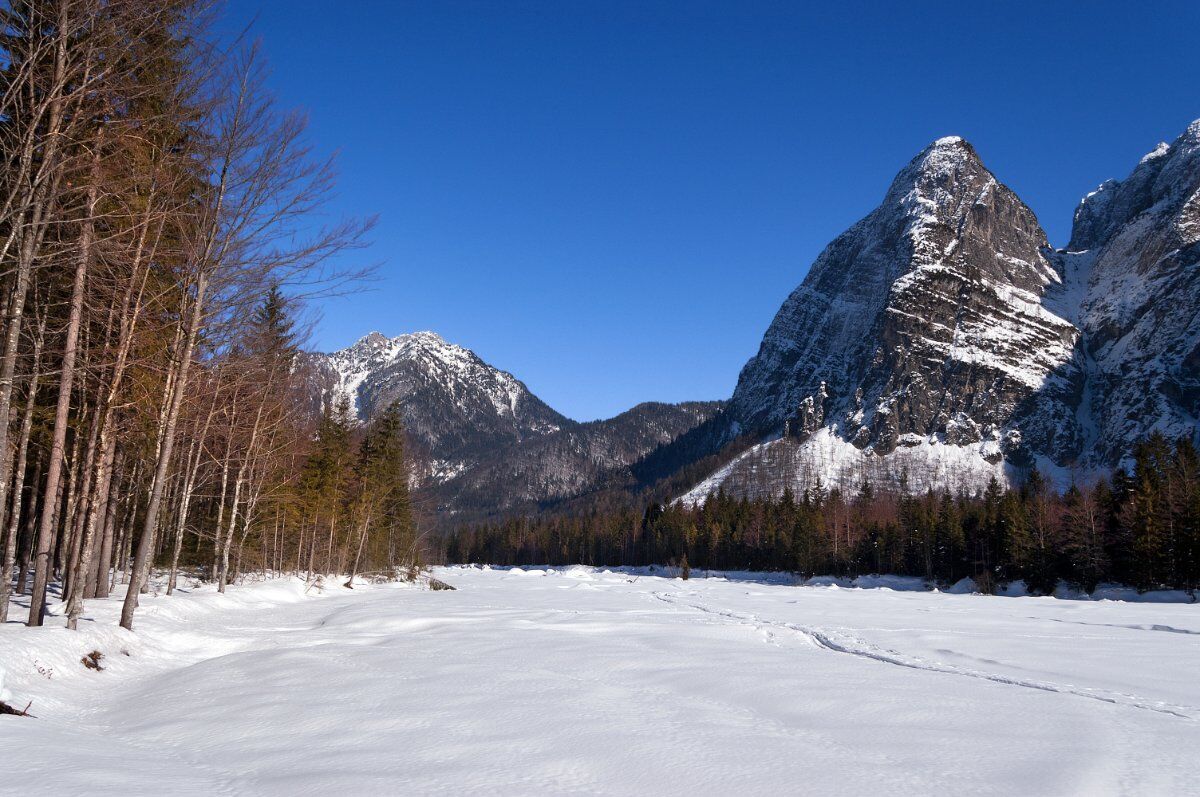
[650,592,1200,721]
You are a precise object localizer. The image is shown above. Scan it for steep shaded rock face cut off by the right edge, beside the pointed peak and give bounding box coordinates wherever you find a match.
[1063,120,1200,462]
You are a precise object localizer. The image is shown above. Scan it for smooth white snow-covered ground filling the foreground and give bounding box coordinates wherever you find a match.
[0,568,1200,797]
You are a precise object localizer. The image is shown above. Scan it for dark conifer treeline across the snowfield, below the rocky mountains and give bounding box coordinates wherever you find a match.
[445,435,1200,594]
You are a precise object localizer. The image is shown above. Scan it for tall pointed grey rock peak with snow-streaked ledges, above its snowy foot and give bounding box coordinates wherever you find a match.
[731,137,1073,451]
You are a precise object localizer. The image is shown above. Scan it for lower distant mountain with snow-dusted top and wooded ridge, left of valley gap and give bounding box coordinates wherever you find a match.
[307,331,720,515]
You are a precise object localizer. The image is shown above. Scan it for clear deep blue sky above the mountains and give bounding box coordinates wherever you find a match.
[223,0,1200,420]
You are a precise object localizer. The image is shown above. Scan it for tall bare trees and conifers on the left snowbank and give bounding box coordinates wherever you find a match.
[0,0,414,628]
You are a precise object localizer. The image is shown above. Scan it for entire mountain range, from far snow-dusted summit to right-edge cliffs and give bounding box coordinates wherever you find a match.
[304,121,1200,515]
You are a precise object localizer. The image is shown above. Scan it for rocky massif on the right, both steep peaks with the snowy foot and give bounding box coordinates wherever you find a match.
[686,122,1200,501]
